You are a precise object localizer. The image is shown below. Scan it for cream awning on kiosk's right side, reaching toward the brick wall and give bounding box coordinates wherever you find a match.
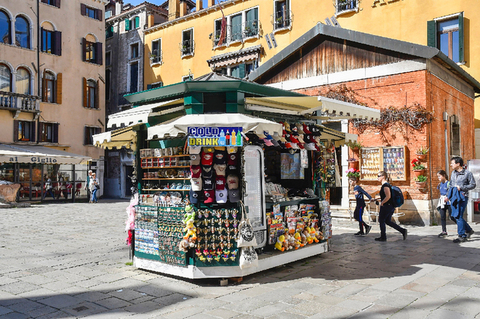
[245,96,380,120]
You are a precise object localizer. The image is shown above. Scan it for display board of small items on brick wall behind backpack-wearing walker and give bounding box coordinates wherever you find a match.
[360,146,406,181]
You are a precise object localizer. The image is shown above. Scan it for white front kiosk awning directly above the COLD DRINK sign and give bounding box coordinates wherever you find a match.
[148,113,282,140]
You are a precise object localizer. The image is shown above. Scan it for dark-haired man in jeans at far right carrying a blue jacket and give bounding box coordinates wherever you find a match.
[445,157,477,243]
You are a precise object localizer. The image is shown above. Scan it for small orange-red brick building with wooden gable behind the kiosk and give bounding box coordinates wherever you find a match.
[249,24,480,225]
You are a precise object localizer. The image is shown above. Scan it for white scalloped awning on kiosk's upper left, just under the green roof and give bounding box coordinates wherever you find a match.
[107,99,183,128]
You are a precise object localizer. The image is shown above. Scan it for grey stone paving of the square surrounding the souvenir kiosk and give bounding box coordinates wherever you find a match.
[0,201,480,319]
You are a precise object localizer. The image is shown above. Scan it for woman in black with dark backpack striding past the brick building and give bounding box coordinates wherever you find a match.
[375,171,407,241]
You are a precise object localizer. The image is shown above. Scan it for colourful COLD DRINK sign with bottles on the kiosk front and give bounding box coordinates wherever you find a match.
[188,127,243,146]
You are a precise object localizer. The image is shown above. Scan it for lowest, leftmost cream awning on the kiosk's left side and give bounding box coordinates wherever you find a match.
[93,125,137,151]
